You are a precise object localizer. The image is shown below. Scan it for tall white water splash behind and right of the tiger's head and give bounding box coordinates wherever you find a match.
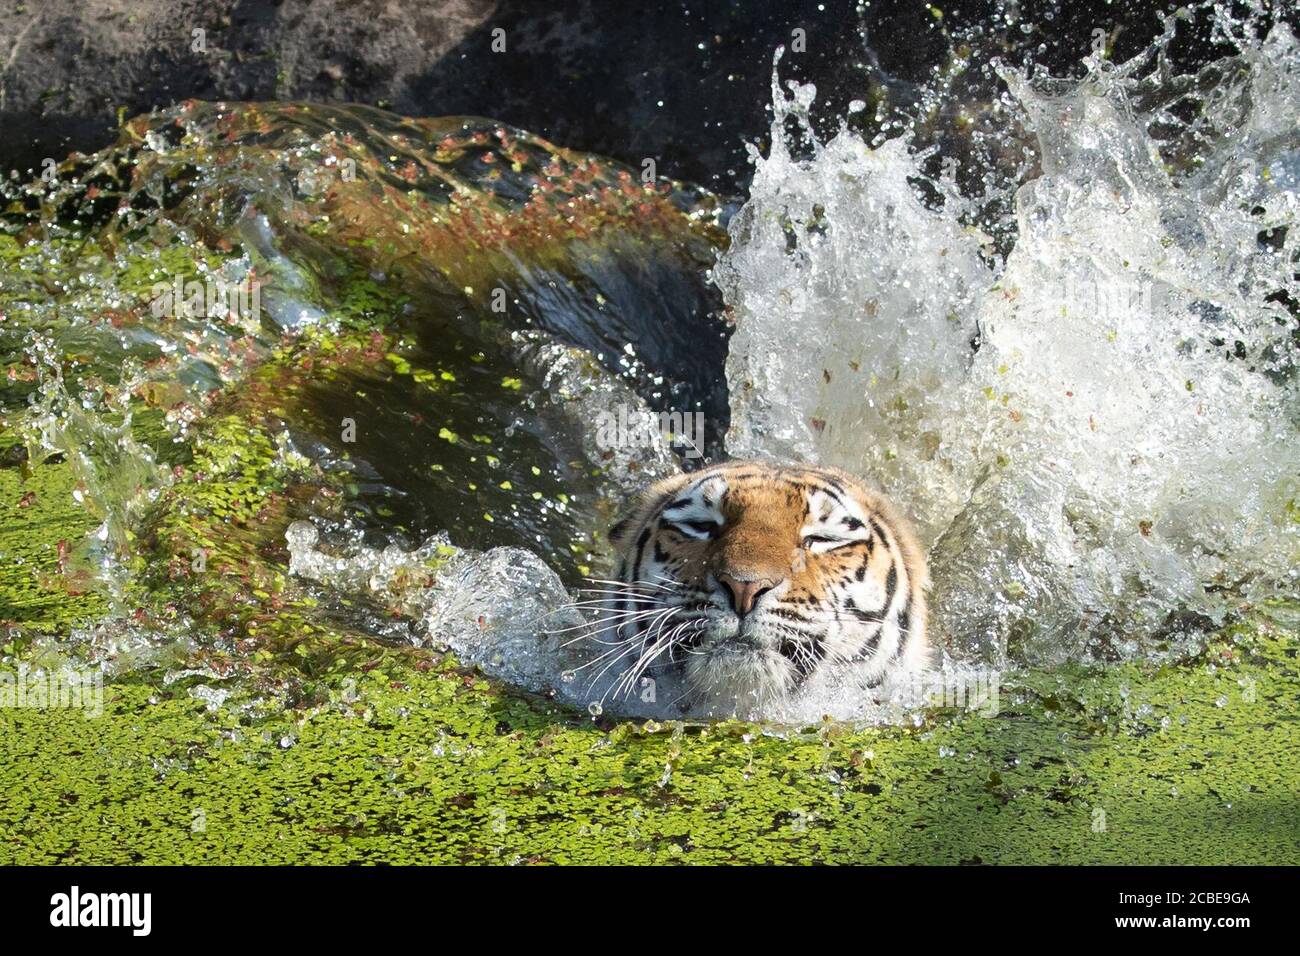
[718,18,1300,663]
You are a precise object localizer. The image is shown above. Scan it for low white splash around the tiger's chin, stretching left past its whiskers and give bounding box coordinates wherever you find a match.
[285,522,956,724]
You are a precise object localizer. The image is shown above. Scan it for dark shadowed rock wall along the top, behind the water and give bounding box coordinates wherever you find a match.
[0,0,1279,193]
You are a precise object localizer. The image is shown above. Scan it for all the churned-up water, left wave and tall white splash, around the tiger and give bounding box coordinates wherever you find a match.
[0,0,1300,722]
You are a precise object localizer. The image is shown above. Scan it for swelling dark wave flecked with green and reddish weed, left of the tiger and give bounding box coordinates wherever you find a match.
[0,104,725,696]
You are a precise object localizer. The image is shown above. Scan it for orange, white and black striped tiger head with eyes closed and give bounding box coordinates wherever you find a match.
[610,462,930,714]
